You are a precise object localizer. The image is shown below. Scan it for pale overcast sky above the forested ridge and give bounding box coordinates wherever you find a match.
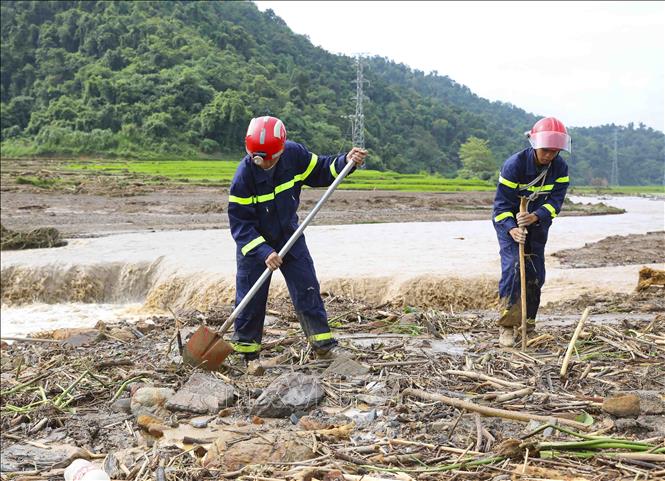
[254,1,665,131]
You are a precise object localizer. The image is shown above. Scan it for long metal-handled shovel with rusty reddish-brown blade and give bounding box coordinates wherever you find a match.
[182,162,355,371]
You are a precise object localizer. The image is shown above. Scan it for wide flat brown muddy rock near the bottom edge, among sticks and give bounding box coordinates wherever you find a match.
[203,428,316,471]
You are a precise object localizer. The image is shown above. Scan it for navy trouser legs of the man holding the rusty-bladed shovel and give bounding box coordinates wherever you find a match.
[232,244,337,349]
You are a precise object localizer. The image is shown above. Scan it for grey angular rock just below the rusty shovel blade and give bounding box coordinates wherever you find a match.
[166,372,235,414]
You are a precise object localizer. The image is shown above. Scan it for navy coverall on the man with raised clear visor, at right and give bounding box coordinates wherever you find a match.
[492,148,569,320]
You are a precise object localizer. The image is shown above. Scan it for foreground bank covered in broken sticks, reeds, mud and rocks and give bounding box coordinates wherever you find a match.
[1,298,665,481]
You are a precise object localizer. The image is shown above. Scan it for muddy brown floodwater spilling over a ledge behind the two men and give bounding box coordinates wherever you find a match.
[1,193,665,336]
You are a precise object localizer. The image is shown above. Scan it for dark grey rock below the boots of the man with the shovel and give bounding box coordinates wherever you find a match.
[251,372,325,418]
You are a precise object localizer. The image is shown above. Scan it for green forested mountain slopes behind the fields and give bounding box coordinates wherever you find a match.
[1,1,665,185]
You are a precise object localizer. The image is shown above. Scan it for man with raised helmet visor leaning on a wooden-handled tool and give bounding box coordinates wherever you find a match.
[492,117,571,347]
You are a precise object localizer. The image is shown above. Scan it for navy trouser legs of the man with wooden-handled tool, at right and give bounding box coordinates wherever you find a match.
[497,228,547,319]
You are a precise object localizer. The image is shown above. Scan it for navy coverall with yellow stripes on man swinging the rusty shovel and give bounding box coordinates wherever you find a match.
[228,141,346,356]
